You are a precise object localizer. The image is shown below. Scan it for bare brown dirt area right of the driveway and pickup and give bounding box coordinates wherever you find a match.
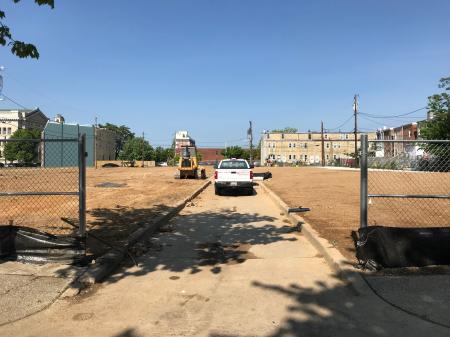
[256,167,450,260]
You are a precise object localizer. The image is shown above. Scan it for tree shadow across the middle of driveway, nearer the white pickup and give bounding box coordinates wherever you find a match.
[100,209,297,283]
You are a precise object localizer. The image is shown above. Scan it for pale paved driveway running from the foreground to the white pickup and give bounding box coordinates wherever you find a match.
[0,186,450,337]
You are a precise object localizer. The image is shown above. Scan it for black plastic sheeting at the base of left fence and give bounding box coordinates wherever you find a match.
[0,226,86,264]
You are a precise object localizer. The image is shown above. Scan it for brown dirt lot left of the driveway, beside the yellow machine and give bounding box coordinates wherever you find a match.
[0,167,211,252]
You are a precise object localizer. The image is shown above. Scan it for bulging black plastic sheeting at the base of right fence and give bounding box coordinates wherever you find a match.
[354,226,450,269]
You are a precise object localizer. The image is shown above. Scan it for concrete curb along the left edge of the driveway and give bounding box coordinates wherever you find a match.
[74,179,211,288]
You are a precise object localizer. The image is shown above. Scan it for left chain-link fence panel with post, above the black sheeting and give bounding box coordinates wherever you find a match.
[0,136,86,237]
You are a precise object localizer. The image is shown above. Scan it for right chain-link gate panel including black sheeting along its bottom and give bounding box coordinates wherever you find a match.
[354,135,450,269]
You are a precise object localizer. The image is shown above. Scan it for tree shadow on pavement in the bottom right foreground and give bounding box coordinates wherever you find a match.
[209,275,450,337]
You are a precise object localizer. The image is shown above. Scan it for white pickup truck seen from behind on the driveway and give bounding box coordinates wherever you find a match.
[214,158,253,195]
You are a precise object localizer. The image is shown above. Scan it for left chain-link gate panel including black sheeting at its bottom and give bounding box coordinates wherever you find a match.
[0,134,86,262]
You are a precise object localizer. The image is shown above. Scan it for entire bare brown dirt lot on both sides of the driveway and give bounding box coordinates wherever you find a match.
[0,167,450,259]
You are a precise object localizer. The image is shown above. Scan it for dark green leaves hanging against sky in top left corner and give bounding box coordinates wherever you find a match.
[0,0,55,59]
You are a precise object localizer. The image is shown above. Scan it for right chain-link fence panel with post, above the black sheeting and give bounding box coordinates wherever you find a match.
[361,138,450,227]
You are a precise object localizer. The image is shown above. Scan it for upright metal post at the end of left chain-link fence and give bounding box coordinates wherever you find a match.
[78,133,86,237]
